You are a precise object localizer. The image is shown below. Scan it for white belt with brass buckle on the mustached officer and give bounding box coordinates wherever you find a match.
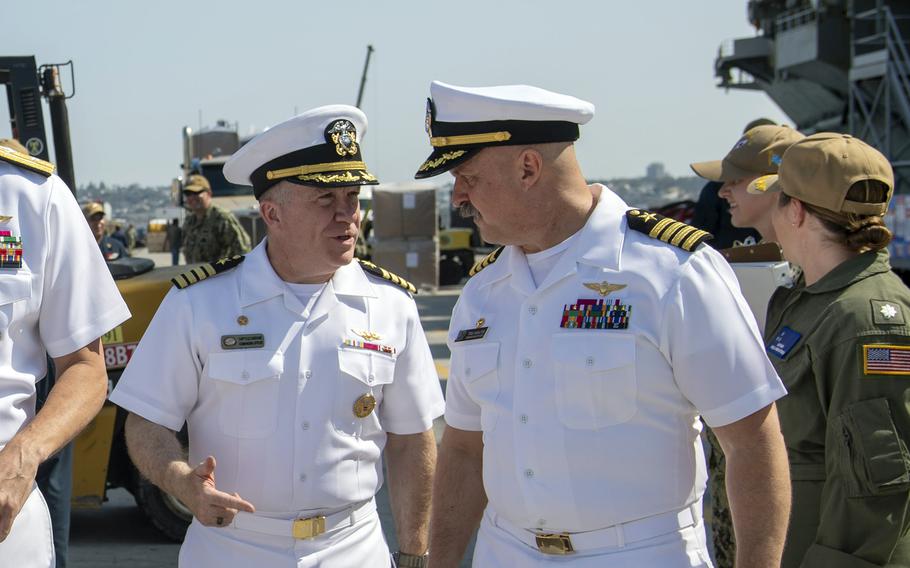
[490,504,701,555]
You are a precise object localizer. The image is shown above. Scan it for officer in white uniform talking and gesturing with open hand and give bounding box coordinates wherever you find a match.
[111,105,443,568]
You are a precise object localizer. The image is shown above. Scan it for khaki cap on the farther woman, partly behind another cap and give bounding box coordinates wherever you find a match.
[690,125,805,182]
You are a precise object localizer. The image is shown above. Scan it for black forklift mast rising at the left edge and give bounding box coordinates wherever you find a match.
[0,55,76,194]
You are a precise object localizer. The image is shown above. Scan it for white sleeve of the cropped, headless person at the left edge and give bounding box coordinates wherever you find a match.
[37,176,130,357]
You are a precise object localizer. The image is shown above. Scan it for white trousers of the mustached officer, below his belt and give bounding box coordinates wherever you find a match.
[472,508,713,568]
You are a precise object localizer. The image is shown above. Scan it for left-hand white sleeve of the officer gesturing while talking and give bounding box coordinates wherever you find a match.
[110,288,202,431]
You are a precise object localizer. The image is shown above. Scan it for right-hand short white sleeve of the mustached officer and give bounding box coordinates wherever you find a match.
[661,247,787,426]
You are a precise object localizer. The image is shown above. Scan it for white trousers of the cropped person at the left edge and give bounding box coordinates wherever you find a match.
[0,485,56,568]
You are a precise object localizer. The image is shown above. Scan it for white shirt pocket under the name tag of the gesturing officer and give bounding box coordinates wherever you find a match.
[206,349,284,438]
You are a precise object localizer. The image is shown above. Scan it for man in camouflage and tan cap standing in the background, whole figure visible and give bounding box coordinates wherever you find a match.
[183,175,250,264]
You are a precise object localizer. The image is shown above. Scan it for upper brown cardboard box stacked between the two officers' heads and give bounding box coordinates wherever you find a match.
[372,182,439,239]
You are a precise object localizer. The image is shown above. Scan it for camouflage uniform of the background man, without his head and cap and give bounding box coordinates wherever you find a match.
[183,205,250,263]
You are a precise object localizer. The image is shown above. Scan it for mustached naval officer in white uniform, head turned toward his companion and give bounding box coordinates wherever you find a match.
[417,82,790,568]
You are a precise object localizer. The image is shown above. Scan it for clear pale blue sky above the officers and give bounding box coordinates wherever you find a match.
[0,0,787,185]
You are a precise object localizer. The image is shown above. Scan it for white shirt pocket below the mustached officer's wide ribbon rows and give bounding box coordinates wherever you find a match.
[551,332,638,430]
